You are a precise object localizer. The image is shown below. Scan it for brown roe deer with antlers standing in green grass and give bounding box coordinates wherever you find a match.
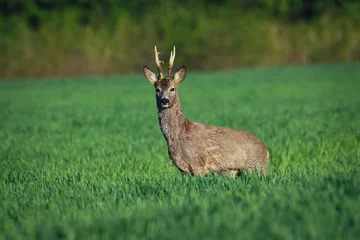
[143,46,269,178]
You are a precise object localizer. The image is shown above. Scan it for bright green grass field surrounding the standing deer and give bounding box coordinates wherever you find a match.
[0,64,360,239]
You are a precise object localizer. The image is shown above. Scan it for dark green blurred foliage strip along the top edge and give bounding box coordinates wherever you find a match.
[0,0,360,22]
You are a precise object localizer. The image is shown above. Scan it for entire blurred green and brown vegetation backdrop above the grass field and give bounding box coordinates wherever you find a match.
[0,0,360,79]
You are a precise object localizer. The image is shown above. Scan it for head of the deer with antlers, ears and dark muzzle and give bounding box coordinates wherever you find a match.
[143,46,186,109]
